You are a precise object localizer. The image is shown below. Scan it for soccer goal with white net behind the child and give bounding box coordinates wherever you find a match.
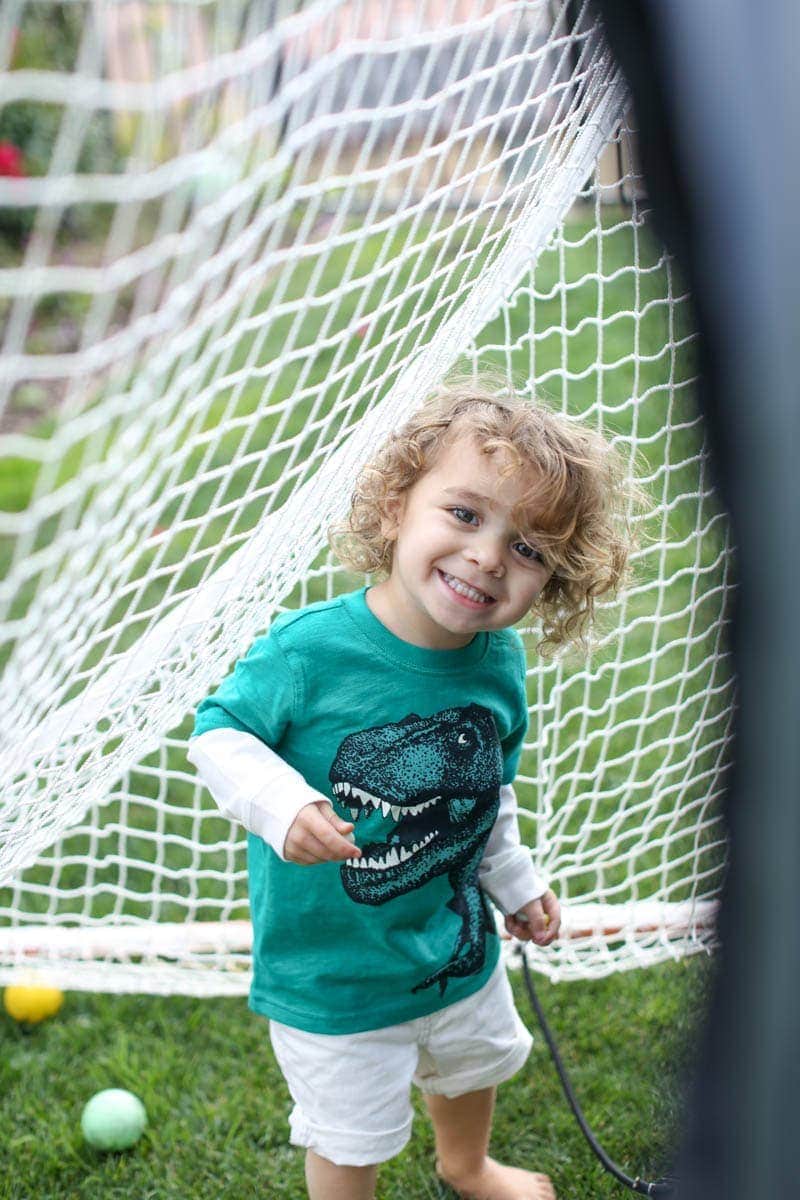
[0,0,733,995]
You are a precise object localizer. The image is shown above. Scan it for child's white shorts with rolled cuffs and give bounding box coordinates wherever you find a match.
[270,960,533,1166]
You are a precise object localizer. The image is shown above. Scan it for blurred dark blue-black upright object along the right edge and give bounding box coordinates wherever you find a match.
[596,0,800,1200]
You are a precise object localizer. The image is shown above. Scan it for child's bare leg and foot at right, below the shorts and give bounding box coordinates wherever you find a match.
[425,1087,555,1200]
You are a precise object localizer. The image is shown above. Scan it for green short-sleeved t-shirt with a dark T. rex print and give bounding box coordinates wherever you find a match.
[194,588,528,1033]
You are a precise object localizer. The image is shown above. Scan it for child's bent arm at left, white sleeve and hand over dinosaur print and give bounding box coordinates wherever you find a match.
[187,728,360,863]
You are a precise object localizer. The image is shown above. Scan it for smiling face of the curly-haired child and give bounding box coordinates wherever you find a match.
[369,436,552,649]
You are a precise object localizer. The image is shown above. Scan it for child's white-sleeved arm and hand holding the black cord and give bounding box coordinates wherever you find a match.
[479,784,560,944]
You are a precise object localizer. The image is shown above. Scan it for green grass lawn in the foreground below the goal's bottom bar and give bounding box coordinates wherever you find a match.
[0,959,710,1200]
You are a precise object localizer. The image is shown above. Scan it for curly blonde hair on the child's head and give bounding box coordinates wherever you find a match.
[331,374,642,653]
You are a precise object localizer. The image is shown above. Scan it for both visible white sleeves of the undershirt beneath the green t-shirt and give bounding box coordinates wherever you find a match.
[187,728,548,913]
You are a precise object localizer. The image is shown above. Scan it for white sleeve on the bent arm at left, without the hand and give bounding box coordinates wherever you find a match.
[187,728,330,862]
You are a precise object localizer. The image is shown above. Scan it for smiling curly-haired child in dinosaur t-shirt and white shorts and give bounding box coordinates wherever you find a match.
[190,380,628,1200]
